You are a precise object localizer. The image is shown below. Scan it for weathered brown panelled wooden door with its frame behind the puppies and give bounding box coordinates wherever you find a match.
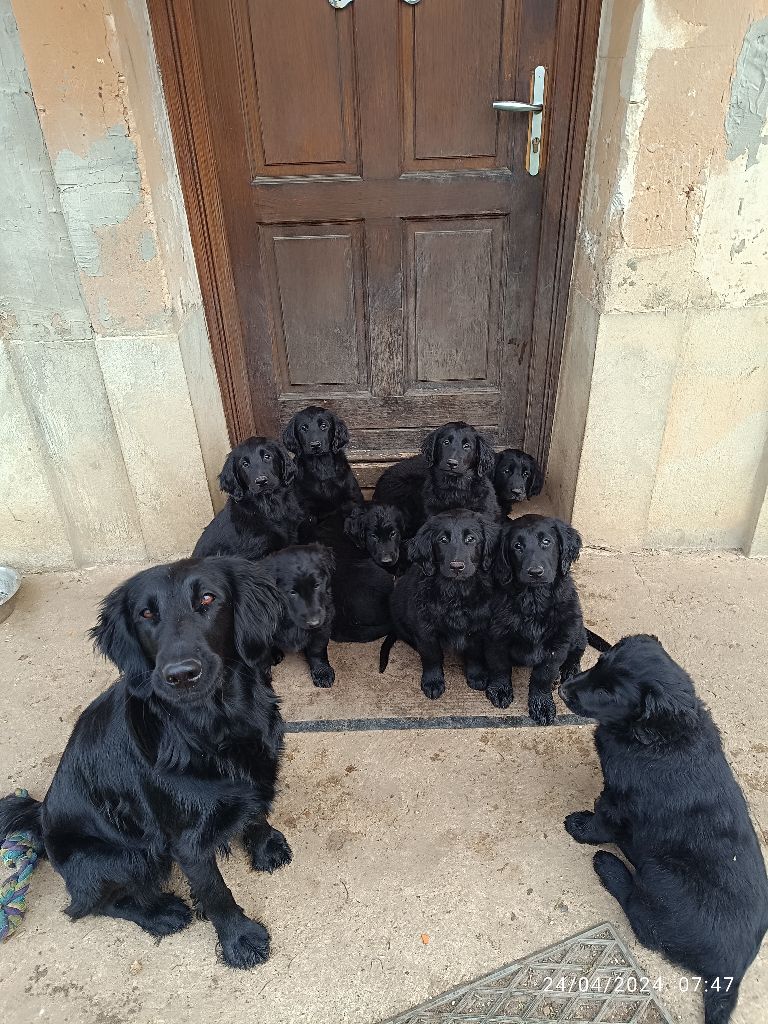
[151,0,599,482]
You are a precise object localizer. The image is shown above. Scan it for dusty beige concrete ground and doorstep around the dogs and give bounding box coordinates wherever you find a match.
[0,550,768,1024]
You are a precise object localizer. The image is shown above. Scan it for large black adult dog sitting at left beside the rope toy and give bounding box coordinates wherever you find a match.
[0,558,291,968]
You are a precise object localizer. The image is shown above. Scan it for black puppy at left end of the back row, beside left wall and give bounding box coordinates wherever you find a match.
[193,437,304,559]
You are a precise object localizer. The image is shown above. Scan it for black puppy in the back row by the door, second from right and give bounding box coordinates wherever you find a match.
[374,421,501,535]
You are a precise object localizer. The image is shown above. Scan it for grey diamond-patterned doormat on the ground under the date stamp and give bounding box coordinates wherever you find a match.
[383,924,673,1024]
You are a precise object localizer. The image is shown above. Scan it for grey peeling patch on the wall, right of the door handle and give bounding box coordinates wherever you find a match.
[725,17,768,167]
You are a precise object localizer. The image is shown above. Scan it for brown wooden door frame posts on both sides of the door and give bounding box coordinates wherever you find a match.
[146,0,602,465]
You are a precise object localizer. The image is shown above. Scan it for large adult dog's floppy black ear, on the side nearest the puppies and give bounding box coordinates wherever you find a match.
[231,558,285,664]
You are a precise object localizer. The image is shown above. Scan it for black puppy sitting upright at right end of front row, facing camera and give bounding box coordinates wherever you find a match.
[485,515,587,725]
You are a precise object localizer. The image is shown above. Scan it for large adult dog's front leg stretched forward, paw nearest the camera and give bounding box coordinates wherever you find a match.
[175,849,269,968]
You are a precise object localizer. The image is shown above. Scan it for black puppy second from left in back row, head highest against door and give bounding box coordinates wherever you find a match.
[283,406,364,520]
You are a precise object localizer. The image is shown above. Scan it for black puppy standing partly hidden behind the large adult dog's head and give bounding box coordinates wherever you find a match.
[259,544,336,687]
